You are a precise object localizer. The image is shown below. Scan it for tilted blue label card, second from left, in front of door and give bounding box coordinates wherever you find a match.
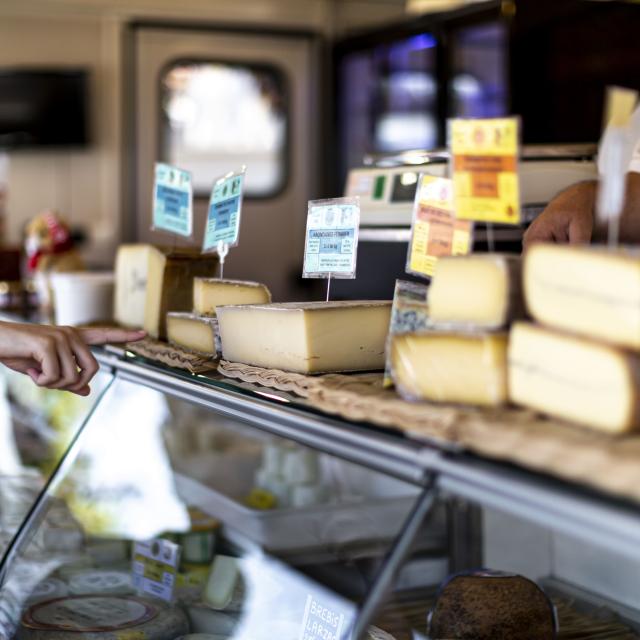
[202,168,245,252]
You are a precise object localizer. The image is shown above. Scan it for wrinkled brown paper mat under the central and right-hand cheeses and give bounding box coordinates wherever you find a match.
[218,361,640,501]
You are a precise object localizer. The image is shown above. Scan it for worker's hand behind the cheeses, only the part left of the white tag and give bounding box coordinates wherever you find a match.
[522,182,596,249]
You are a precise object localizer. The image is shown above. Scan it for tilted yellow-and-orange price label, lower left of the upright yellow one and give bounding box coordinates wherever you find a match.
[406,175,473,277]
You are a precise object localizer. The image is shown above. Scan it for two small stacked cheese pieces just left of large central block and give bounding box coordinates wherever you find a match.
[167,278,271,356]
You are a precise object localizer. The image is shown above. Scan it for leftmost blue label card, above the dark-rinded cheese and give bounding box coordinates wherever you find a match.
[152,162,193,238]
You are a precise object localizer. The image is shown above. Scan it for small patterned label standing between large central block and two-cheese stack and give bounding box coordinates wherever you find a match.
[382,280,429,388]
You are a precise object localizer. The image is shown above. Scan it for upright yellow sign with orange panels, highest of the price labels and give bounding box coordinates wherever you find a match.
[449,118,520,224]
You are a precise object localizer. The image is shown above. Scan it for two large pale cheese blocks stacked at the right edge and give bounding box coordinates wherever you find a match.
[509,245,640,432]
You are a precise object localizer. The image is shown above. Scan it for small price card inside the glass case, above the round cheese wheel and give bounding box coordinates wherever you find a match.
[132,538,180,602]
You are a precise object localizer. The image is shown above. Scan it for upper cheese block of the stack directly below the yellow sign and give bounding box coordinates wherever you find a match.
[429,254,524,329]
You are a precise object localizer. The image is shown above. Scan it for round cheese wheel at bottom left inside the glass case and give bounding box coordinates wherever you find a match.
[18,595,189,640]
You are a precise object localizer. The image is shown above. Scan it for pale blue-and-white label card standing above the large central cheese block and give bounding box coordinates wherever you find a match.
[302,198,360,278]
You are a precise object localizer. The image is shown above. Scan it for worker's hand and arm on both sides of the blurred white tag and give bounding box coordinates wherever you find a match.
[523,172,640,249]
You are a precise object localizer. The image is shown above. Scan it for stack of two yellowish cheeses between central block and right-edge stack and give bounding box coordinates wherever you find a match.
[390,254,524,406]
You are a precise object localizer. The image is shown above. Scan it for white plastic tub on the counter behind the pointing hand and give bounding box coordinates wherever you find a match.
[51,271,115,325]
